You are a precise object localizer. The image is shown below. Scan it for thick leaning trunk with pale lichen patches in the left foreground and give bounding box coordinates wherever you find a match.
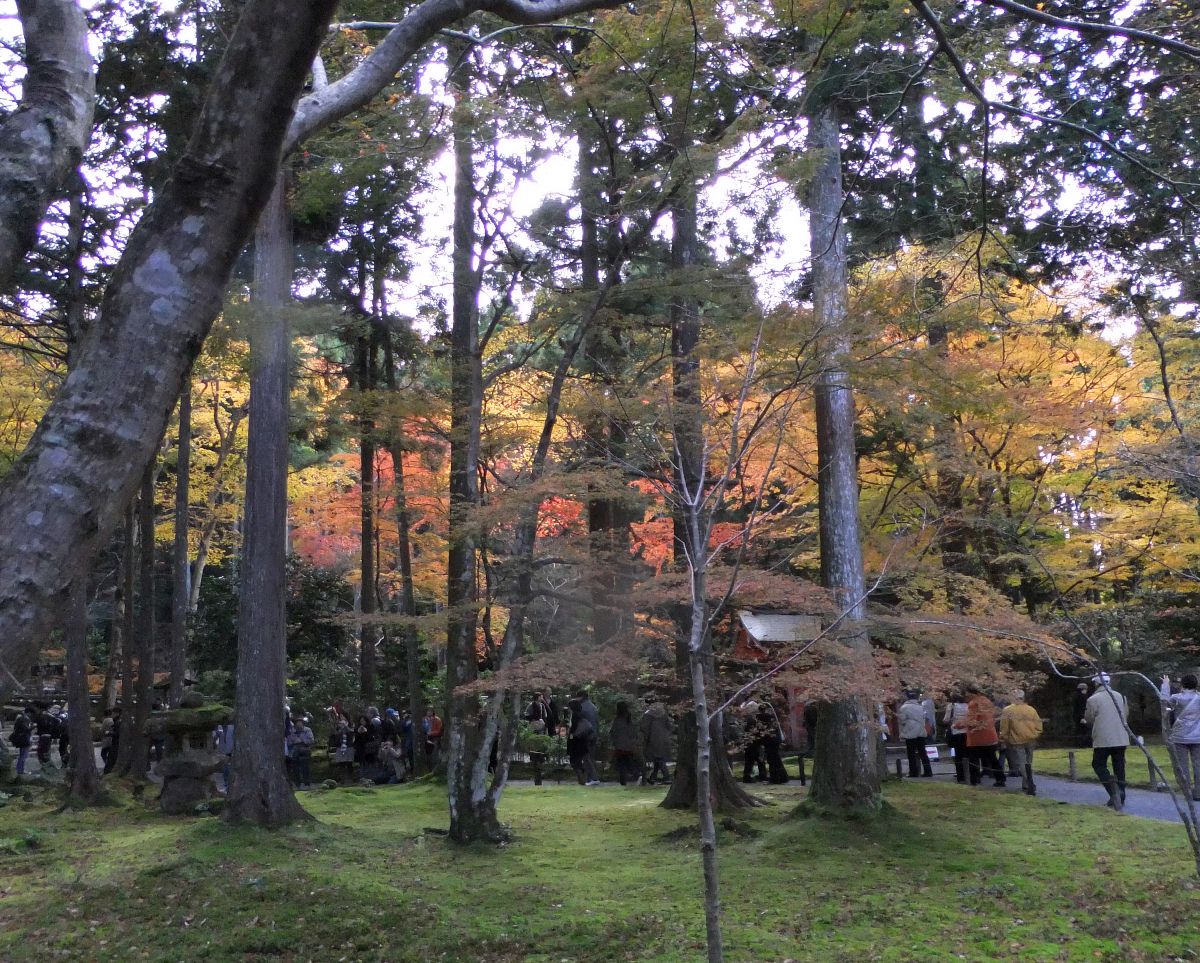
[0,0,335,684]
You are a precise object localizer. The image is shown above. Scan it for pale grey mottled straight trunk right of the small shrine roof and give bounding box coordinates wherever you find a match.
[809,104,880,809]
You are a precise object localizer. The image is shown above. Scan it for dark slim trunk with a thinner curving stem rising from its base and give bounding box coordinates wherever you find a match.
[446,43,505,843]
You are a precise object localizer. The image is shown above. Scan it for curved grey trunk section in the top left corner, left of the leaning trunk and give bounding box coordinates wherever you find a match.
[0,0,96,289]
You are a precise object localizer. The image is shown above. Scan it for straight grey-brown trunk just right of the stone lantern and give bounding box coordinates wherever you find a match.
[222,172,307,829]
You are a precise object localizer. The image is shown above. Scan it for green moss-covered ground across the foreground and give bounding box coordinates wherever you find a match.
[0,780,1200,963]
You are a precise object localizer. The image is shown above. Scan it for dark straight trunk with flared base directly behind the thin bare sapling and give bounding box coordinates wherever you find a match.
[662,165,756,811]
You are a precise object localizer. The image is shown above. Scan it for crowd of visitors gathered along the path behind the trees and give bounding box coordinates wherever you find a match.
[7,672,1200,812]
